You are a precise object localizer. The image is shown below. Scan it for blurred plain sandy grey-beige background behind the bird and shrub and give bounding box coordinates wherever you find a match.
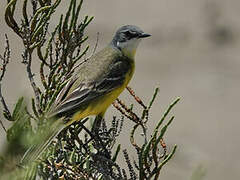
[0,0,240,180]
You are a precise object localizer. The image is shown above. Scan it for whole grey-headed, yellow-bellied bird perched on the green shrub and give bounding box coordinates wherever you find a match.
[21,25,151,163]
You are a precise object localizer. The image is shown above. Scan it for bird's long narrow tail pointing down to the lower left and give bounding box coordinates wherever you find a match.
[21,118,65,165]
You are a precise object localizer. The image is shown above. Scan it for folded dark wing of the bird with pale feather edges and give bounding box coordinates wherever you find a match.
[52,60,131,116]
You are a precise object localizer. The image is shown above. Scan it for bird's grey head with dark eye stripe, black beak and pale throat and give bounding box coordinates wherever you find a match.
[111,25,150,58]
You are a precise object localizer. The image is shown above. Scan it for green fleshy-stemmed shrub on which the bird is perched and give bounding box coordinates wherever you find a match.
[0,0,179,179]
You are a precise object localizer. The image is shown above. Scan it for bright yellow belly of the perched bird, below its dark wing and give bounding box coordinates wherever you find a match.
[70,66,134,124]
